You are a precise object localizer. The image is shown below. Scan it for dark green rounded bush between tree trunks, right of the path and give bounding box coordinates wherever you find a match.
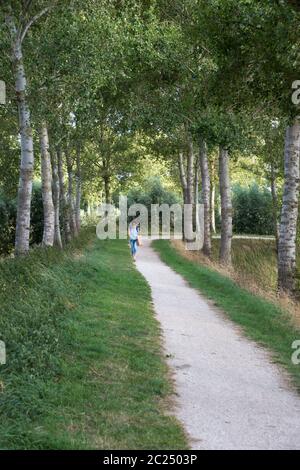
[232,184,274,235]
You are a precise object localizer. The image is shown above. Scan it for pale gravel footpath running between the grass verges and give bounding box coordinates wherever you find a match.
[136,241,300,449]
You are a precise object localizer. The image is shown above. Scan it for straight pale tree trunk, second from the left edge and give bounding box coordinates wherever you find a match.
[40,124,54,246]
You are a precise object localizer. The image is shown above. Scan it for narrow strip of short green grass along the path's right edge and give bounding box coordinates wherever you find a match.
[153,240,300,391]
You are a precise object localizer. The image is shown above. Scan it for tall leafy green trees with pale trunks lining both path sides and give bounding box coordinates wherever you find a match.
[0,0,300,295]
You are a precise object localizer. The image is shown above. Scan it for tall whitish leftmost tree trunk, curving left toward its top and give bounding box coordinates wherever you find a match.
[6,16,34,255]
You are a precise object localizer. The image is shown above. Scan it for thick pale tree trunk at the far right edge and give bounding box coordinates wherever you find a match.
[278,122,300,295]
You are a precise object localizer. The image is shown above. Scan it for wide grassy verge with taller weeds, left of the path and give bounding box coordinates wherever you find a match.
[0,230,187,449]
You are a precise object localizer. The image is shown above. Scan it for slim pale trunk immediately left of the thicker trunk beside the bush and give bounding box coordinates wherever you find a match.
[199,140,211,256]
